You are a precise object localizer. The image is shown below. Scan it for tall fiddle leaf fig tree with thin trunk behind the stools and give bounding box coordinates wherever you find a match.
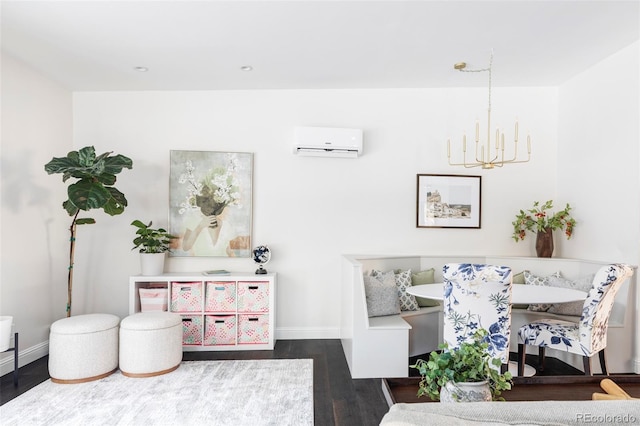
[44,146,133,317]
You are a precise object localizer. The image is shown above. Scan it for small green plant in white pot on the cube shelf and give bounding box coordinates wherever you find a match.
[131,219,176,275]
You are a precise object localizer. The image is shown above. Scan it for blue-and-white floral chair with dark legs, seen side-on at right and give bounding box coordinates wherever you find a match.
[518,264,633,376]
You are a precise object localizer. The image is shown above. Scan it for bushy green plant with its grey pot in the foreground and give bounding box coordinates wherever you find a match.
[410,329,512,402]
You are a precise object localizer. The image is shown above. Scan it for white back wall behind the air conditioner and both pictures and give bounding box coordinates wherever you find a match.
[74,88,557,338]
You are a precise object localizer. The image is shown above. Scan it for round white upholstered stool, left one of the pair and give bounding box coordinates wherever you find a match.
[49,314,120,383]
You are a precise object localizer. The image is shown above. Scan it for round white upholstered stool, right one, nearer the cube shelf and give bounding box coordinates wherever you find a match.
[120,312,182,377]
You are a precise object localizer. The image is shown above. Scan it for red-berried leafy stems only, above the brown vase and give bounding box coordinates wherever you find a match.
[511,200,576,242]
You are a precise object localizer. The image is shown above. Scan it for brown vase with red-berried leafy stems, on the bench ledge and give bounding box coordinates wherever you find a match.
[511,200,576,257]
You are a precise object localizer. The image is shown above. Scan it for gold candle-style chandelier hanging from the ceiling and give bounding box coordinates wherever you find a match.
[447,51,531,169]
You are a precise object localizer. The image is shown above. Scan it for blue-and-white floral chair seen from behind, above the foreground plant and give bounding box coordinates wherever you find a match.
[442,263,512,369]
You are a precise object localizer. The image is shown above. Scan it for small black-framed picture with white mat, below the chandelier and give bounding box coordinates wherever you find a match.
[416,174,482,229]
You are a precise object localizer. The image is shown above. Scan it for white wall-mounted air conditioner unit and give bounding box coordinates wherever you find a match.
[293,127,362,158]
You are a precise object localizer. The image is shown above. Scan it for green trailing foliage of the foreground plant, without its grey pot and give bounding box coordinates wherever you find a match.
[410,329,512,401]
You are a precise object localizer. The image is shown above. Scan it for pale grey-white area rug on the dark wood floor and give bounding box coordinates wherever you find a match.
[0,359,313,426]
